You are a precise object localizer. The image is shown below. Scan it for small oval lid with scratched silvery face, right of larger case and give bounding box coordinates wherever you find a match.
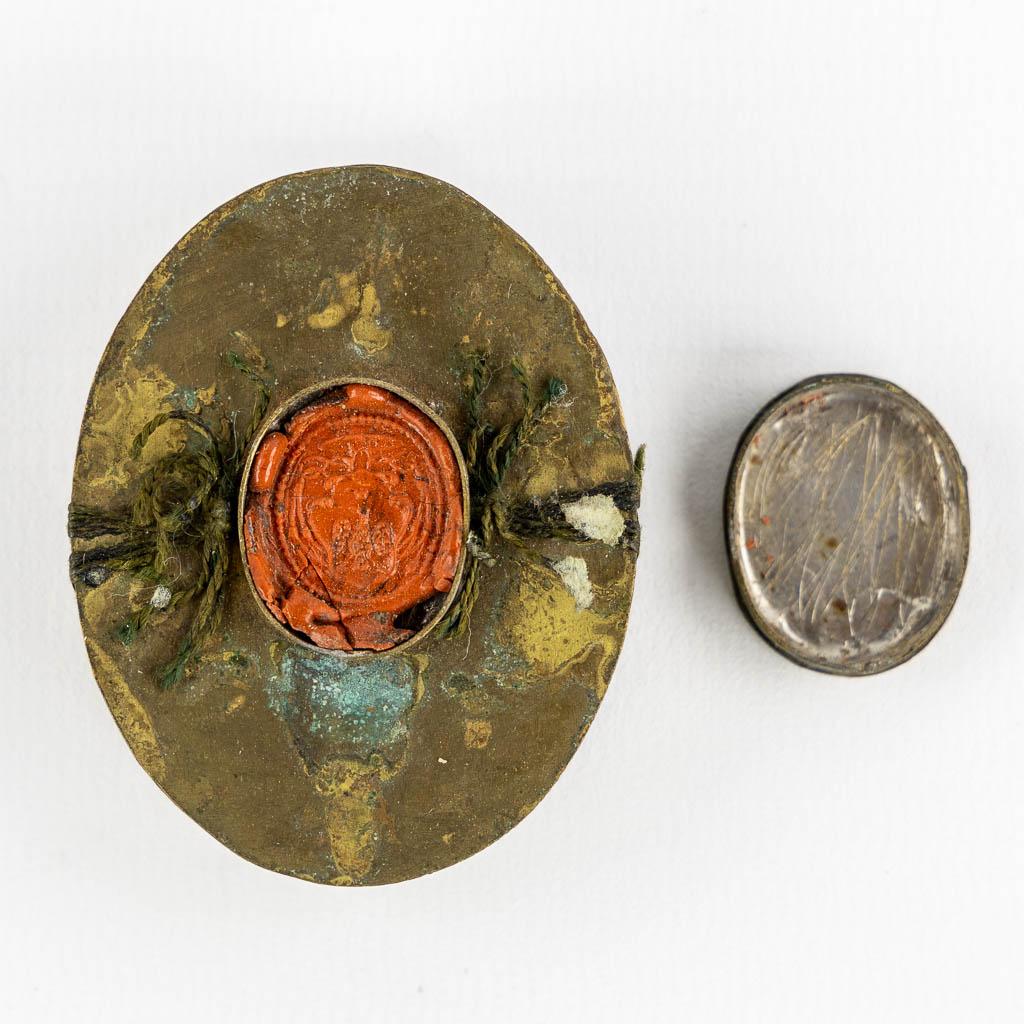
[726,374,970,676]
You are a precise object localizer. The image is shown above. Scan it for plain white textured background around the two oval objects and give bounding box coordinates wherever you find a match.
[0,0,1024,1024]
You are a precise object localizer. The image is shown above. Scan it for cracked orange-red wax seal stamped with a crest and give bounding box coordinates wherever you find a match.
[244,384,463,650]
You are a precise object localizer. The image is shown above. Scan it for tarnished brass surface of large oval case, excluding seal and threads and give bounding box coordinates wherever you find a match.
[73,167,636,885]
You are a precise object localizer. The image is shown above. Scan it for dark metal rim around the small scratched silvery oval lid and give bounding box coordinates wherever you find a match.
[723,373,971,676]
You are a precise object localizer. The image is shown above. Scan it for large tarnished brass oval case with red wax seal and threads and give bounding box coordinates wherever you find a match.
[69,167,640,885]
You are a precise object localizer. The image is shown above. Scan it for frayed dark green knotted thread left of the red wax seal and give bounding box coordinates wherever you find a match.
[68,351,270,689]
